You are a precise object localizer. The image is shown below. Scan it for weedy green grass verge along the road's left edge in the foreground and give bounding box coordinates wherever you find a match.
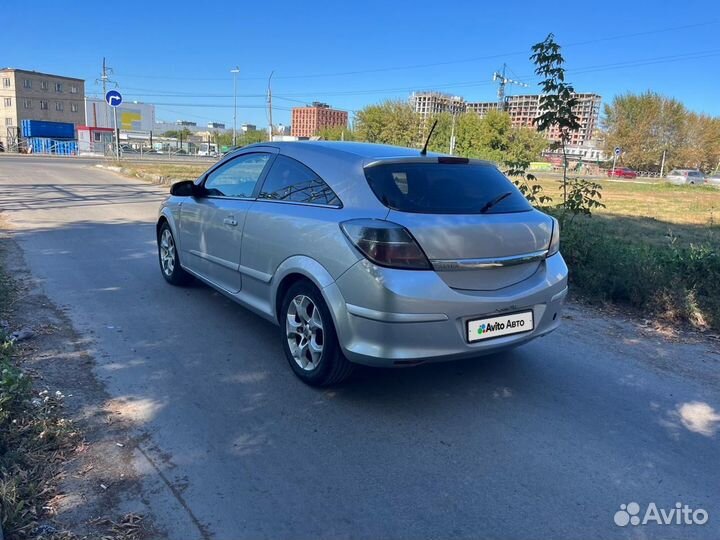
[0,250,144,540]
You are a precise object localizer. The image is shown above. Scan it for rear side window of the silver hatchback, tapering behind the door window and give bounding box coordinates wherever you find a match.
[258,156,340,206]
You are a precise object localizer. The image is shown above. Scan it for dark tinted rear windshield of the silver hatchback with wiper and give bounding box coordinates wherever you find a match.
[365,163,532,214]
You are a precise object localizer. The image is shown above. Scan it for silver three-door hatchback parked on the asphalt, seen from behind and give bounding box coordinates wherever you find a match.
[157,142,568,385]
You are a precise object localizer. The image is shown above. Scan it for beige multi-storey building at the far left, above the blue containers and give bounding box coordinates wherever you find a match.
[0,68,85,146]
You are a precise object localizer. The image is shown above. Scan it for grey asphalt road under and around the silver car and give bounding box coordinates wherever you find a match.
[0,158,720,540]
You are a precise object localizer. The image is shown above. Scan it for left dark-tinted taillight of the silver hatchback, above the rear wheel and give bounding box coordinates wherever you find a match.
[340,219,431,270]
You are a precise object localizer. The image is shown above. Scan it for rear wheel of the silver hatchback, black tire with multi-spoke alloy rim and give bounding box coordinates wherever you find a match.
[278,280,354,386]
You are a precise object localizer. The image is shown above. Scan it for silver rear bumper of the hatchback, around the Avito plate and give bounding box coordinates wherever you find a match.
[323,254,567,366]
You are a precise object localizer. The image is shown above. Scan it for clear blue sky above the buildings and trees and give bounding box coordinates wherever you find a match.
[5,0,720,126]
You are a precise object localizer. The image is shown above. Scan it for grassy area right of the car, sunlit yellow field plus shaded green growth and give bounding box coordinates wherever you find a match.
[539,176,720,331]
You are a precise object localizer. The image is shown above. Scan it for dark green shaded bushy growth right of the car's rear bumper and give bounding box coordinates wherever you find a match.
[561,218,720,330]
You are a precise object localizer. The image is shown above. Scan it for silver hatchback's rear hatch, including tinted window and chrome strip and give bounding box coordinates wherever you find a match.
[365,158,553,291]
